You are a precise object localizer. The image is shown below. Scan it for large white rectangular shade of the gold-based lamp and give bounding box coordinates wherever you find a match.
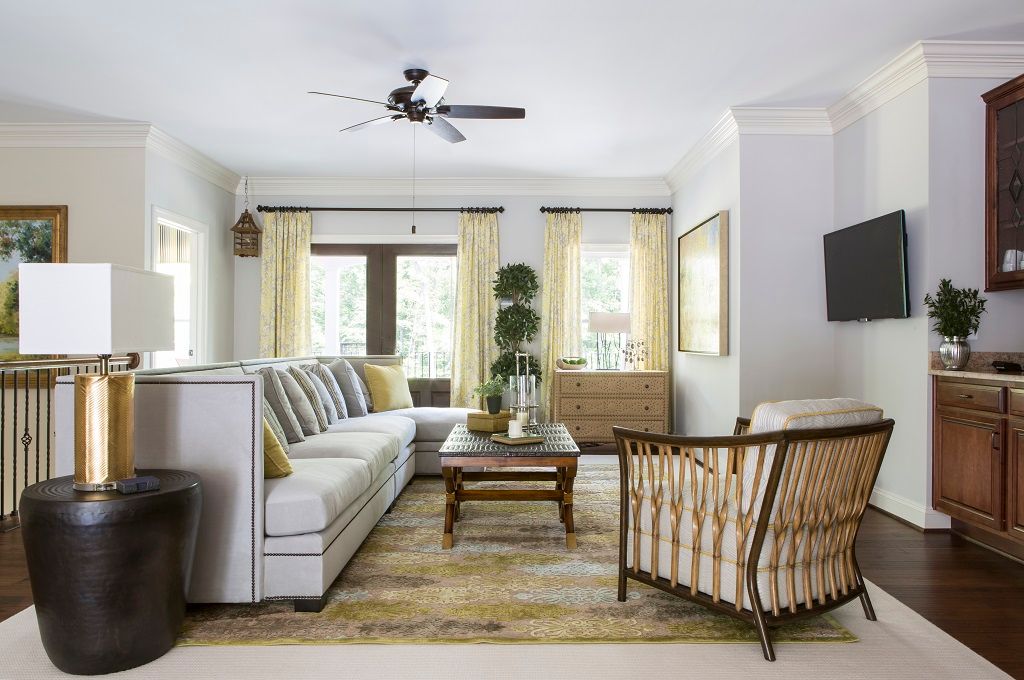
[17,263,174,354]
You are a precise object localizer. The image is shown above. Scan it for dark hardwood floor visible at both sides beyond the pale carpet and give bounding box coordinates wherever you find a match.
[0,510,1024,679]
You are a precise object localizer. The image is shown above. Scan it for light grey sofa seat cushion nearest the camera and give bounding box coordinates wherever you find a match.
[263,456,374,536]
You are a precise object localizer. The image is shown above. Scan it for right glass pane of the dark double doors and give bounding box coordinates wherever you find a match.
[395,256,456,378]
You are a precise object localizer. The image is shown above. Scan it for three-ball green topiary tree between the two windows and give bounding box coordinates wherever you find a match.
[490,262,541,384]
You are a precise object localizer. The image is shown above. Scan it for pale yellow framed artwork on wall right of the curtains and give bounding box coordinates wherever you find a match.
[677,210,729,356]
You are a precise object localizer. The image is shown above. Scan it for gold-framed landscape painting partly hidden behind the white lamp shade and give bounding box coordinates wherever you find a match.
[0,206,68,362]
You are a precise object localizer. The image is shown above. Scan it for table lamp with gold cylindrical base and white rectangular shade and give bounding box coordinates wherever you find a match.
[17,263,174,491]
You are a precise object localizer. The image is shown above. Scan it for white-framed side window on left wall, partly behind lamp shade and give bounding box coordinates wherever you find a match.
[153,218,203,369]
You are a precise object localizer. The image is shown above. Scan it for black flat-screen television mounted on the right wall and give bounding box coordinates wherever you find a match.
[824,210,910,322]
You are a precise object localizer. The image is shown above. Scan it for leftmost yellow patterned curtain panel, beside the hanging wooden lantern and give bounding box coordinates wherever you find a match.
[259,212,312,357]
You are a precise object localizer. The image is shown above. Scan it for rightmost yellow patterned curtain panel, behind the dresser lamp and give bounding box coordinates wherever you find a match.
[630,213,669,371]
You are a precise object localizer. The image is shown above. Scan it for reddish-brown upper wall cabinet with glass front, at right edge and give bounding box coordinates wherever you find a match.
[982,76,1024,291]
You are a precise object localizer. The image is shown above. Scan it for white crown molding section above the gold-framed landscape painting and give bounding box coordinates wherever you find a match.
[0,123,150,148]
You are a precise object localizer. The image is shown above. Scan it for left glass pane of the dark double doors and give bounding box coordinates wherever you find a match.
[309,255,367,356]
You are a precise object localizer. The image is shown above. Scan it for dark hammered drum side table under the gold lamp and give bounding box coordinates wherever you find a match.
[20,470,203,675]
